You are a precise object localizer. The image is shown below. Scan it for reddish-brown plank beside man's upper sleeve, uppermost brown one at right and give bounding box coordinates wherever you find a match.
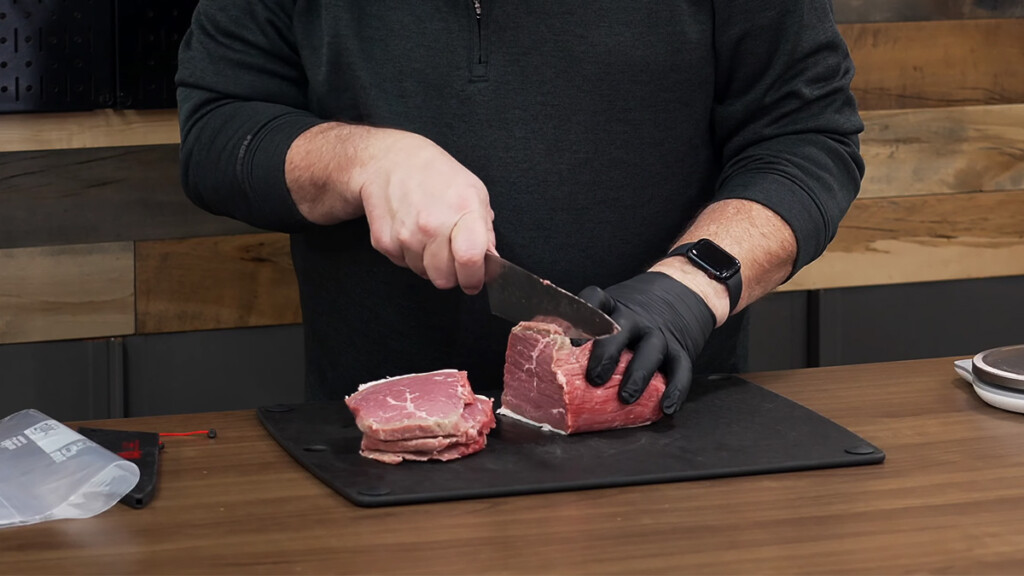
[840,18,1024,110]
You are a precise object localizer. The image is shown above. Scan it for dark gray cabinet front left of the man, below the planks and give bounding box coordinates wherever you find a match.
[0,326,304,421]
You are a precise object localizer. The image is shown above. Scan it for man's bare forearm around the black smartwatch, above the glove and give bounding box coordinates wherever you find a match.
[651,200,797,326]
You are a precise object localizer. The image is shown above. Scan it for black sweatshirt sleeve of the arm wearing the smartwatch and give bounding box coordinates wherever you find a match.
[713,0,864,274]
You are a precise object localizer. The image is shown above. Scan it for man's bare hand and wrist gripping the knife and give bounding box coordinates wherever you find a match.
[286,122,495,294]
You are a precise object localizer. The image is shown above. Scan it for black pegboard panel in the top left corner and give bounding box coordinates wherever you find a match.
[0,0,115,112]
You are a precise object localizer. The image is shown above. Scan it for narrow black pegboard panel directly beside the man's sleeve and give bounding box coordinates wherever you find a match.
[115,0,199,109]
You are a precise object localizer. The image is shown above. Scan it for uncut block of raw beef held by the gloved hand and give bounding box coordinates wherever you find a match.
[498,322,665,434]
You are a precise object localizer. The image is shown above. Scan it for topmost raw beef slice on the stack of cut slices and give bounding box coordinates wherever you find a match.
[345,370,476,441]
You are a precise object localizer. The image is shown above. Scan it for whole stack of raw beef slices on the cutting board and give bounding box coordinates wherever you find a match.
[345,370,495,464]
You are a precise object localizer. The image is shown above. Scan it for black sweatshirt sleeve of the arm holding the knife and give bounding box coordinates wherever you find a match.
[175,0,324,232]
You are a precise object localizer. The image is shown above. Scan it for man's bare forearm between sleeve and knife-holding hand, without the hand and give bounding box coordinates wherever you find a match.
[285,122,379,225]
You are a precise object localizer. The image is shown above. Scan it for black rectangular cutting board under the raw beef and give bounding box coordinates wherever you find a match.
[258,376,885,506]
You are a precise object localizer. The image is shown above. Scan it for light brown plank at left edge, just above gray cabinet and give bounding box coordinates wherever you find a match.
[0,242,135,342]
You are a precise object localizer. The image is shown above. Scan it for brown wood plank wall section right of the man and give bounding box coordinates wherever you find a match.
[780,17,1024,291]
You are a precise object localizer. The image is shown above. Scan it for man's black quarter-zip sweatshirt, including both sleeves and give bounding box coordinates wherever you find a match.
[177,0,863,399]
